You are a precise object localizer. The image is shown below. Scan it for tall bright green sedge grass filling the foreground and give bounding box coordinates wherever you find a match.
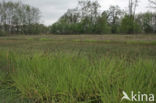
[0,52,156,103]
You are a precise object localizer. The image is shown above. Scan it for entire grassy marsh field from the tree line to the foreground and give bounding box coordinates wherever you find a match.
[0,34,156,103]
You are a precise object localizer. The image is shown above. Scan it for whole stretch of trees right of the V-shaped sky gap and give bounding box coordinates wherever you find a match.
[50,0,156,34]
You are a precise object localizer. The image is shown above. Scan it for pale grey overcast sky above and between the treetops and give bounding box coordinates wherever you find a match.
[4,0,153,25]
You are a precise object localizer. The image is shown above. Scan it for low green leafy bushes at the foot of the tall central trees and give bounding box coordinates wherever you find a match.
[50,10,111,34]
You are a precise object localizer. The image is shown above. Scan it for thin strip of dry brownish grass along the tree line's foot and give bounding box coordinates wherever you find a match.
[0,34,156,41]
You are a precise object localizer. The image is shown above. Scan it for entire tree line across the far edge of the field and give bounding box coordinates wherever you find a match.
[0,0,156,35]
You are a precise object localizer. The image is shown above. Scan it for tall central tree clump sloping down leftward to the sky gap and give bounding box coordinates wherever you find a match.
[51,0,103,34]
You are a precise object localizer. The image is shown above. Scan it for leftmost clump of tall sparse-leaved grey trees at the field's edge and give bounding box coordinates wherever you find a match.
[0,2,45,35]
